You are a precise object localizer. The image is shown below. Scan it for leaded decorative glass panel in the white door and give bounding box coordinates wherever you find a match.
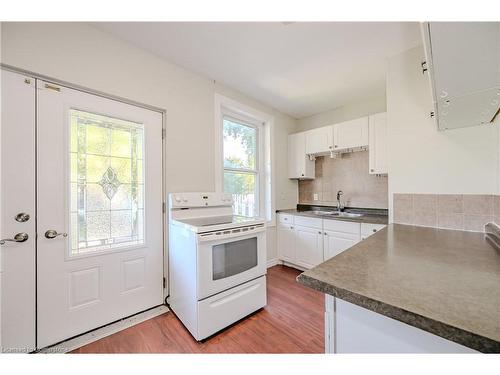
[70,109,144,255]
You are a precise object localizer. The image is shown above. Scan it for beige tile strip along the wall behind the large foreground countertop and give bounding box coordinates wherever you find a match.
[393,194,500,232]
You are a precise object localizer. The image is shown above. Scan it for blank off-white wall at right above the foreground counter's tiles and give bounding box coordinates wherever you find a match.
[386,47,499,220]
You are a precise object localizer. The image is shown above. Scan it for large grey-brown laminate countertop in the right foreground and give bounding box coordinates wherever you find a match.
[297,224,500,353]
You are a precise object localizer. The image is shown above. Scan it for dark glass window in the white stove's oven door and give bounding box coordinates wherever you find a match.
[212,237,257,280]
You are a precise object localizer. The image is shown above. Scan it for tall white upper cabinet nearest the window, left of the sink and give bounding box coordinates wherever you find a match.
[288,133,315,180]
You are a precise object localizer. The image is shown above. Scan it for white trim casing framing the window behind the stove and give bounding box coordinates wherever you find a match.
[214,93,276,226]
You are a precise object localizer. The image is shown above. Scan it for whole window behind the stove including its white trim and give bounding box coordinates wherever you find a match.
[215,94,275,224]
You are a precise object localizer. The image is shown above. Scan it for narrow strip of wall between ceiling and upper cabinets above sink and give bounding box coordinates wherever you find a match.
[297,96,386,131]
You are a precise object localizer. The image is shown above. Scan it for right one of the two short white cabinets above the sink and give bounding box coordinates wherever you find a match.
[333,117,368,151]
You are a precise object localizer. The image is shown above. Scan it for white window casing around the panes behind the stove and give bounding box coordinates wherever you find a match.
[214,93,276,226]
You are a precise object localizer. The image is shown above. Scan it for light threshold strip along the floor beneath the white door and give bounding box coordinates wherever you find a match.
[39,305,170,354]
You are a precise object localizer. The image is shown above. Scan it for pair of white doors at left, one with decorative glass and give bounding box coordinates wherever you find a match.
[0,71,164,351]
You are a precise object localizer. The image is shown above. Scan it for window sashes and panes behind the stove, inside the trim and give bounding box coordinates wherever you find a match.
[222,115,263,216]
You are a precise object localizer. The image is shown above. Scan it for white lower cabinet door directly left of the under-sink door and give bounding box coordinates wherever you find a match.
[295,226,323,268]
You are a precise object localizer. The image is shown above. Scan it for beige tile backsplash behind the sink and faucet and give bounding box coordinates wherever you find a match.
[299,151,388,209]
